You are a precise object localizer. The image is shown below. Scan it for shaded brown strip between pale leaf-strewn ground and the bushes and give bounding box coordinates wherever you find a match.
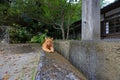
[0,43,40,54]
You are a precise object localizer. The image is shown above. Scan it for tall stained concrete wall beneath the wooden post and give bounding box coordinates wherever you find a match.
[54,41,120,80]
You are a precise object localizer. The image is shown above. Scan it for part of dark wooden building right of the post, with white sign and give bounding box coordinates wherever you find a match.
[101,0,120,38]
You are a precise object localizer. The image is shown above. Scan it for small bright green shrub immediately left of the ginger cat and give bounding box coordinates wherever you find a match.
[30,33,47,45]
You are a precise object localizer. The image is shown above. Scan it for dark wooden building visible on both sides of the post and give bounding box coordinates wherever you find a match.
[69,0,120,39]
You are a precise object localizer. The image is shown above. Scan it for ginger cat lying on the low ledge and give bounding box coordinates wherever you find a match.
[42,38,54,53]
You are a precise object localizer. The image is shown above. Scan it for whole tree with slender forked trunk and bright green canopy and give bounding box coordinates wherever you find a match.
[41,0,81,39]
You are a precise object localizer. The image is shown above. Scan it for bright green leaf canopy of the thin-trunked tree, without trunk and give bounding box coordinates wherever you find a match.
[42,0,81,23]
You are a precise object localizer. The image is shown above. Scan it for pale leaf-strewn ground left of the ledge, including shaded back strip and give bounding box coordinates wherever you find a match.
[0,44,41,80]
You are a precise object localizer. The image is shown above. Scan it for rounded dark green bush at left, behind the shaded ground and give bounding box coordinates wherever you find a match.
[8,24,32,43]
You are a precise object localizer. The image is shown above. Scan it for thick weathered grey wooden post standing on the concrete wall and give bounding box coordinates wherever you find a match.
[82,0,100,40]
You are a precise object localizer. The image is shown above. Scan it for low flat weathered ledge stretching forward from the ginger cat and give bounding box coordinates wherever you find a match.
[36,51,87,80]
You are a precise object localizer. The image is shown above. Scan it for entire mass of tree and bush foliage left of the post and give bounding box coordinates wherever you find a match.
[0,0,81,43]
